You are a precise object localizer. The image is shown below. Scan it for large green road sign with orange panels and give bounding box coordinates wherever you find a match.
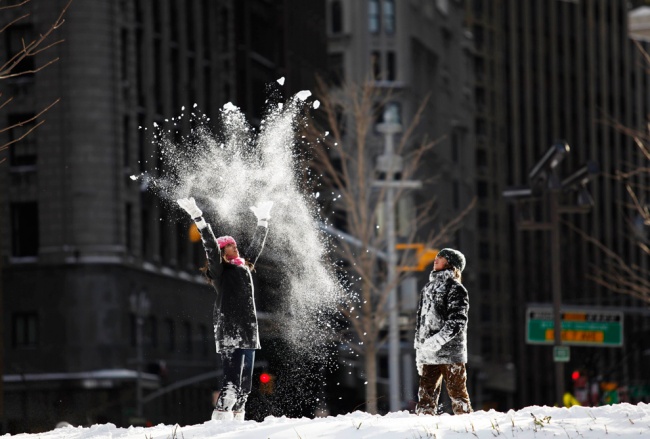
[526,306,623,347]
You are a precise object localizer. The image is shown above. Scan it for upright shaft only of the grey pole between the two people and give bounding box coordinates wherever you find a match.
[385,132,401,412]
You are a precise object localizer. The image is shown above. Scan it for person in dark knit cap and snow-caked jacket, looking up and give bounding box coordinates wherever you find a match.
[415,248,472,415]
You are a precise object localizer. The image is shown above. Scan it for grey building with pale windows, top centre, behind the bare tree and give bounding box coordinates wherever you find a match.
[327,0,483,411]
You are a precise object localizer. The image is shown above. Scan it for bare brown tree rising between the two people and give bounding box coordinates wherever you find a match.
[305,81,475,413]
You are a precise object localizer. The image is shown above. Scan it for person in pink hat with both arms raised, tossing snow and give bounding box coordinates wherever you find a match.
[177,198,273,421]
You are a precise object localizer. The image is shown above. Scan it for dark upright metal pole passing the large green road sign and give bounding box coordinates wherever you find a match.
[548,189,564,407]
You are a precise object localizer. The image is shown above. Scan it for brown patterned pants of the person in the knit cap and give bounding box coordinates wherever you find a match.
[415,363,473,415]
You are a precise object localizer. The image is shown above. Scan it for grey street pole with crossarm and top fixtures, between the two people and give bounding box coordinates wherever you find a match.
[373,106,422,412]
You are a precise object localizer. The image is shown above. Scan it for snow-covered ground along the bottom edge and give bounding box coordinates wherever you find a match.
[5,403,650,439]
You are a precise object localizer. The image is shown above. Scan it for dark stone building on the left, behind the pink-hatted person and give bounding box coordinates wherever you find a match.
[0,0,325,432]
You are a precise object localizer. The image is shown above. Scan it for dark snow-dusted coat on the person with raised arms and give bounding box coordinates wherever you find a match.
[199,224,268,352]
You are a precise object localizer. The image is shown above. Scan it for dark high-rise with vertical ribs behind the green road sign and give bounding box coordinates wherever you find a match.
[465,0,649,406]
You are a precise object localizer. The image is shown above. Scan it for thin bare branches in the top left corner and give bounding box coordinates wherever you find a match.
[0,0,72,163]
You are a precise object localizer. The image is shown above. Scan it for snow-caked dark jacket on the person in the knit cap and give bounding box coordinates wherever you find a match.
[415,270,469,368]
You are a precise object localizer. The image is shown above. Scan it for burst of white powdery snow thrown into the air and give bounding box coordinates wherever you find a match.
[139,87,341,363]
